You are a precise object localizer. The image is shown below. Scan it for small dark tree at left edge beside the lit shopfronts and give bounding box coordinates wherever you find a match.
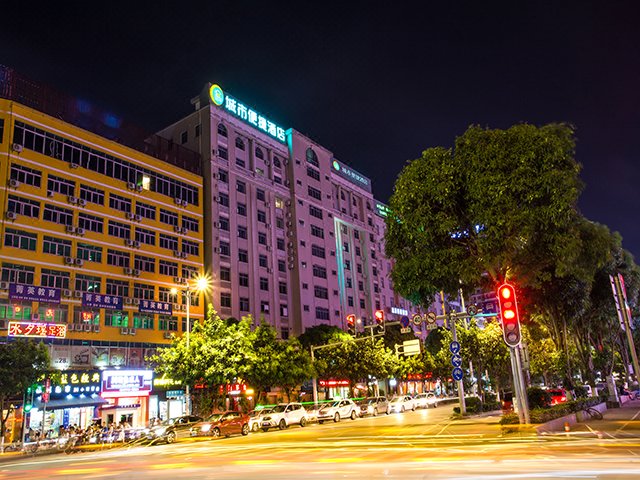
[0,339,50,436]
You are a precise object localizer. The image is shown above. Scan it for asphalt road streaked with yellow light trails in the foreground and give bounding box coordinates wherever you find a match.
[0,406,640,480]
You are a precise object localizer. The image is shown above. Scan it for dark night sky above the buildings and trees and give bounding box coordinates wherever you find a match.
[0,0,640,261]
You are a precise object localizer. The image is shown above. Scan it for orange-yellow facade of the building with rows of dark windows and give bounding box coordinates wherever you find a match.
[0,99,204,344]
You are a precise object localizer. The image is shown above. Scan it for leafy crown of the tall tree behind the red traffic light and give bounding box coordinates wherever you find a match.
[385,124,581,305]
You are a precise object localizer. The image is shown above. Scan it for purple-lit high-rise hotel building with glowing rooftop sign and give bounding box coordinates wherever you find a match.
[158,85,418,338]
